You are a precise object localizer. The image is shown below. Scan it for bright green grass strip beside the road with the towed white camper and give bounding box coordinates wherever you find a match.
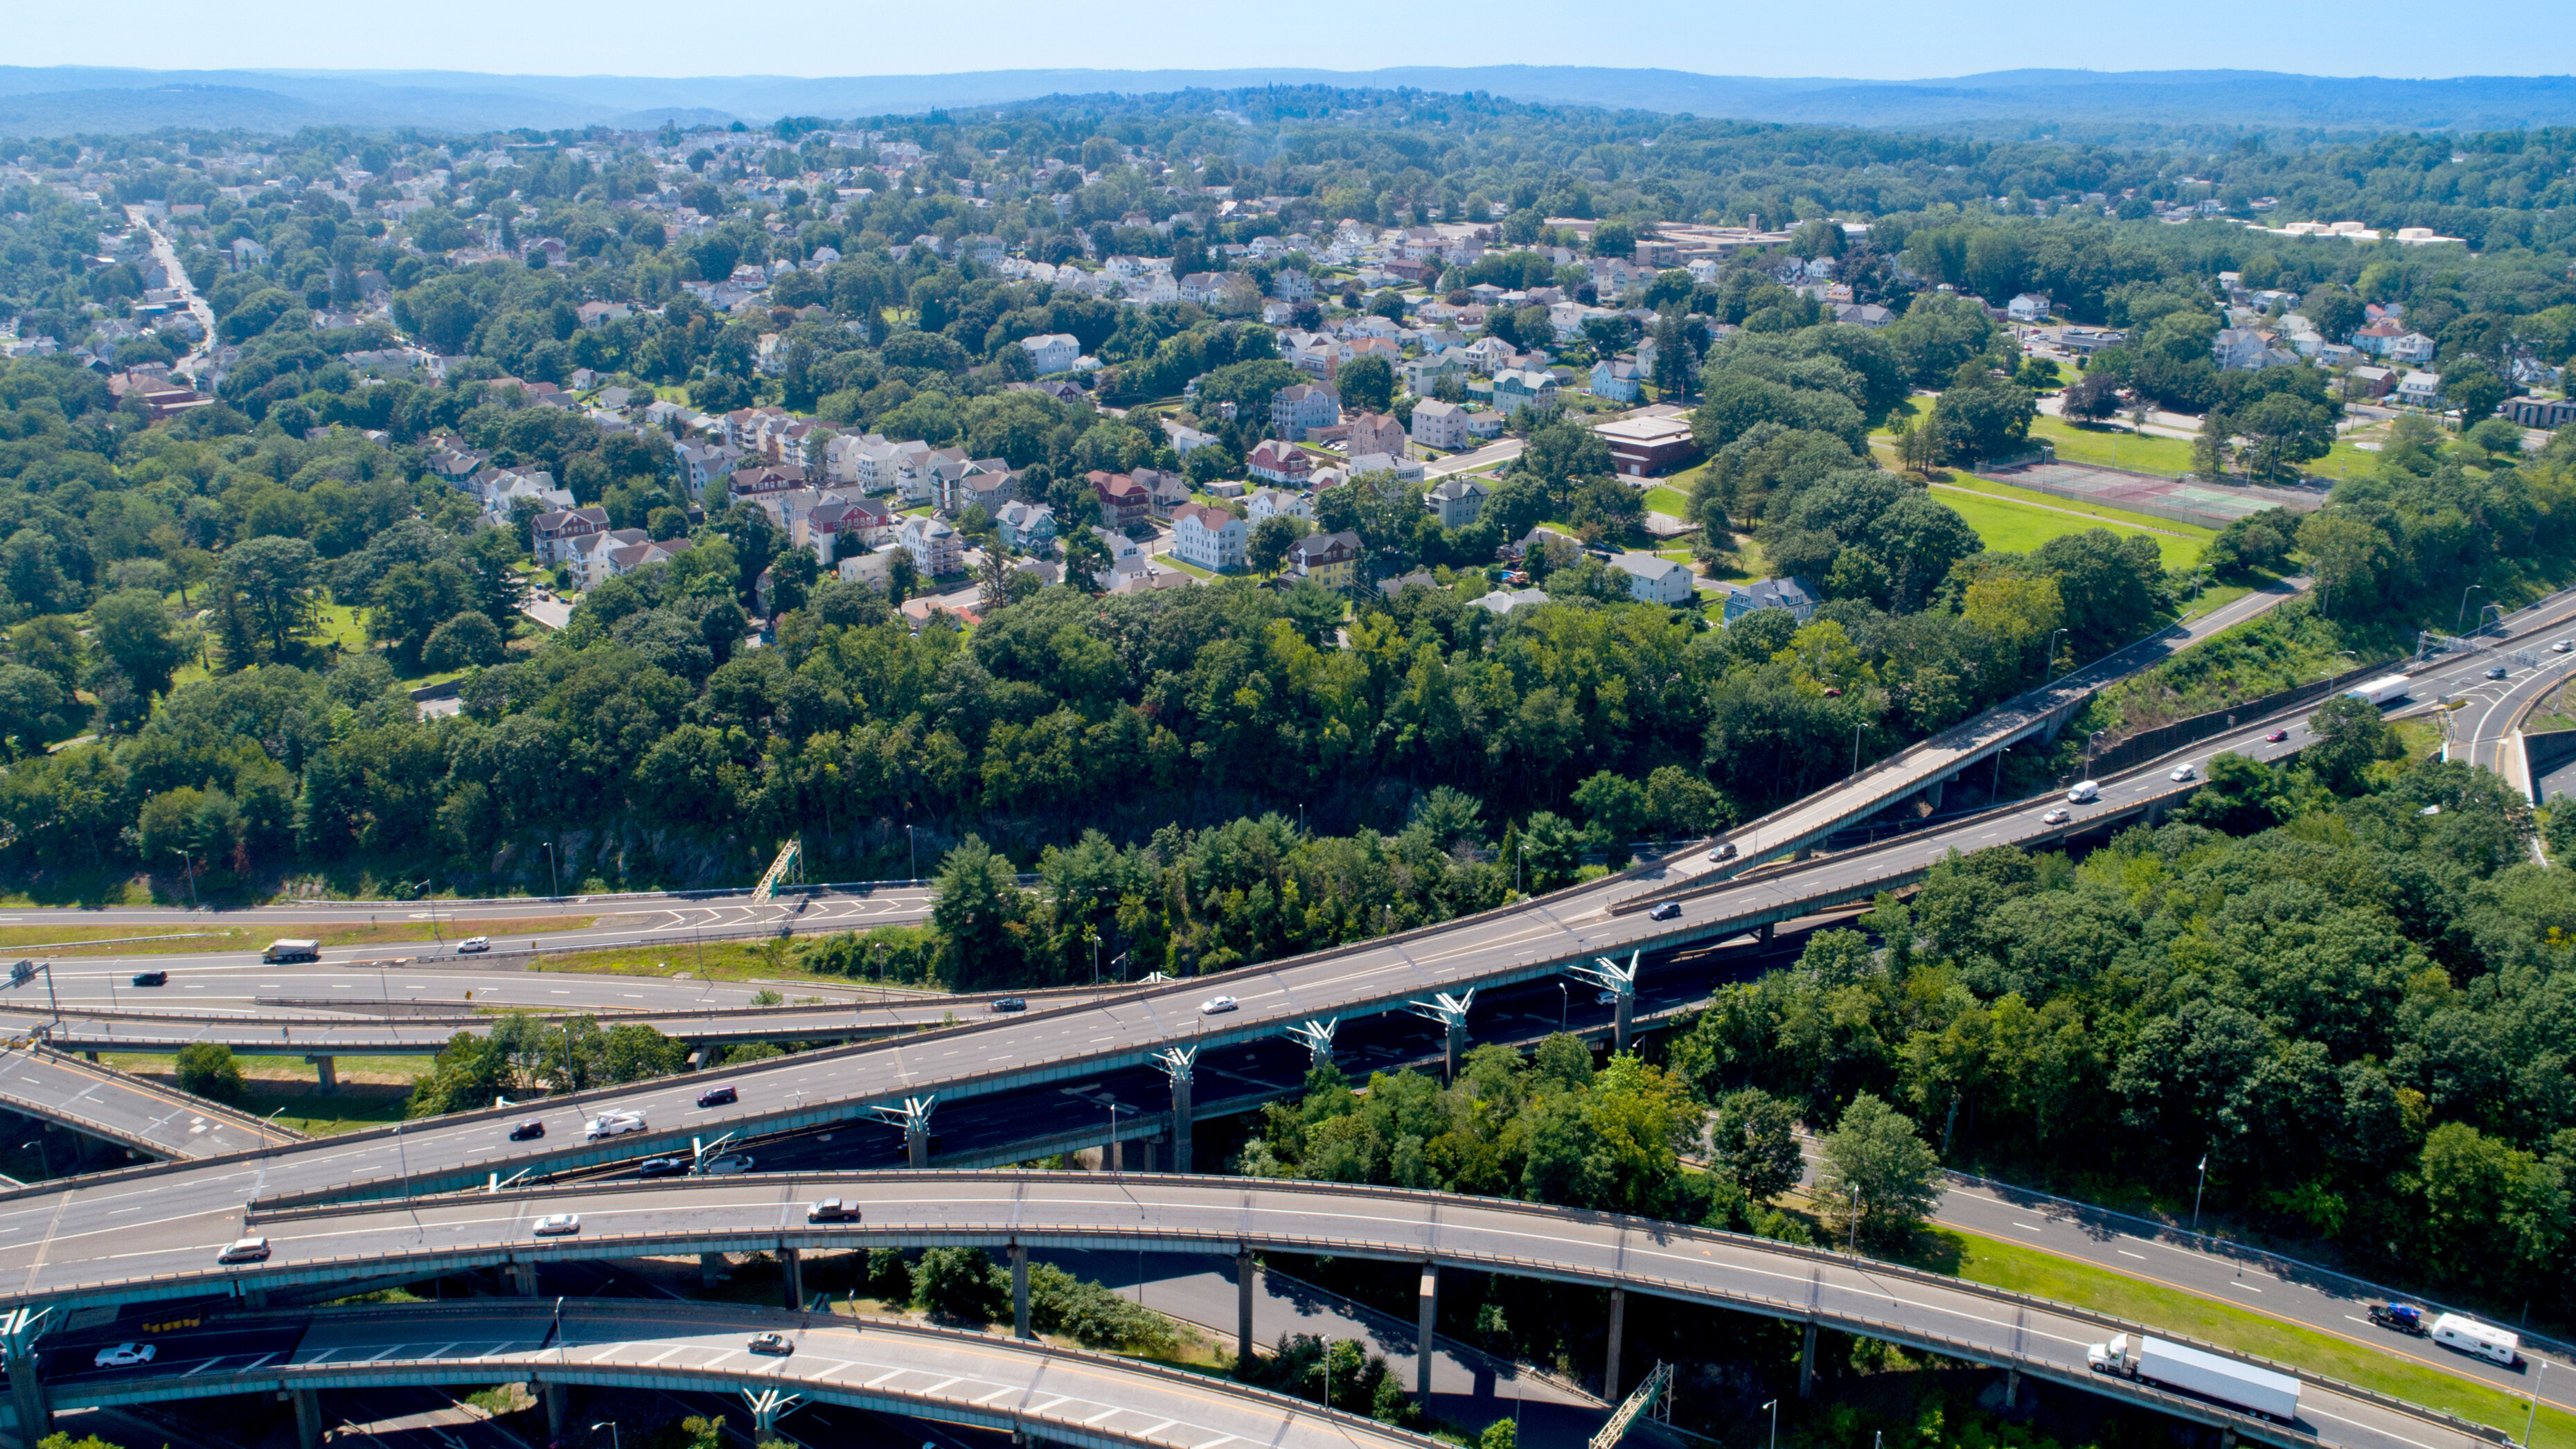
[1903,1227,2576,1449]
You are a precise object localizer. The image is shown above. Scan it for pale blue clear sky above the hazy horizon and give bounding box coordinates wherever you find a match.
[20,0,2576,80]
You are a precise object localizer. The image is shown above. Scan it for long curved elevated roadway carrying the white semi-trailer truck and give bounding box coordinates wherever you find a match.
[0,1171,2534,1449]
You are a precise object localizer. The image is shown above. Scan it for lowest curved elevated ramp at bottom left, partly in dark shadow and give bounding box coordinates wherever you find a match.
[8,1299,1432,1449]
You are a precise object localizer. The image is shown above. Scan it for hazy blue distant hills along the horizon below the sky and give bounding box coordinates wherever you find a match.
[0,64,2576,136]
